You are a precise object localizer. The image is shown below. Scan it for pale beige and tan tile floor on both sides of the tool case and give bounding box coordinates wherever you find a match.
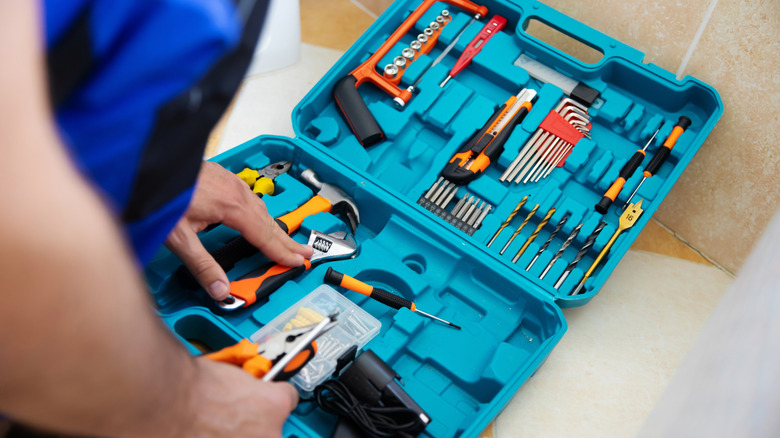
[208,0,732,438]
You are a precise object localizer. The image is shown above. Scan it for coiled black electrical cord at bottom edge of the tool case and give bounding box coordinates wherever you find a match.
[307,380,425,438]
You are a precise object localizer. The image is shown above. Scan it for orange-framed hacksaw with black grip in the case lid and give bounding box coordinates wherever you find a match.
[333,0,488,147]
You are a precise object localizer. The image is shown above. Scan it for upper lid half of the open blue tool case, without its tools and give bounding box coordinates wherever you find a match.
[293,0,723,307]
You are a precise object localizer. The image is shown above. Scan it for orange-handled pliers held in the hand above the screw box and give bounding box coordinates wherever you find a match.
[206,314,337,382]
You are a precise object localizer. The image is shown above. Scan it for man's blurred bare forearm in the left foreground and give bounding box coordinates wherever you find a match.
[0,2,204,436]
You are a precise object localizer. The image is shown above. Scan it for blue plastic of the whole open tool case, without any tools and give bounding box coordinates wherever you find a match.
[146,0,723,437]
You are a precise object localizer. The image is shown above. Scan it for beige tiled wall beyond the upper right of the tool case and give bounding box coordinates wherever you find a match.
[354,0,780,272]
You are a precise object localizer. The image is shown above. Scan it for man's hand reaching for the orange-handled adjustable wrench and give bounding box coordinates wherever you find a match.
[165,161,312,301]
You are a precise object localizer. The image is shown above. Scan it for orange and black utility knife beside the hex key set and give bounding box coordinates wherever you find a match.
[441,88,536,186]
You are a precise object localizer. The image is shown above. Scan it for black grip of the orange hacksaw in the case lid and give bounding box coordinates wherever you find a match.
[333,75,385,147]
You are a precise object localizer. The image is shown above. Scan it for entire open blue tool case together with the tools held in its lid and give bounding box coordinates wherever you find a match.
[147,0,723,437]
